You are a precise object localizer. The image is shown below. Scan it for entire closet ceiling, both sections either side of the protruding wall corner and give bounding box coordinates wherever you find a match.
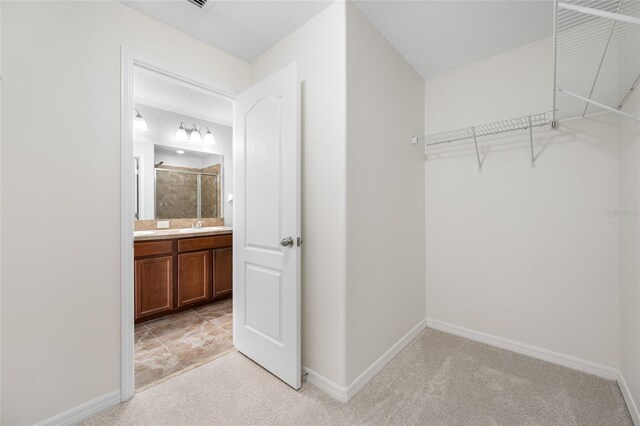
[122,0,553,78]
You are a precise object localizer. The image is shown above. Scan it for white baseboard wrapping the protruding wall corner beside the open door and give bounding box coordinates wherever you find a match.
[303,320,427,402]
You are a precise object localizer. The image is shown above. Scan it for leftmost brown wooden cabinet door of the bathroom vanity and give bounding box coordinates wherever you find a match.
[135,256,173,319]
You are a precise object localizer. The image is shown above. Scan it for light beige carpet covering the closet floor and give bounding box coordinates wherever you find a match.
[85,329,632,425]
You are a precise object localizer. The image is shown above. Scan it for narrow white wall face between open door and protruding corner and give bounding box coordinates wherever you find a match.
[251,2,346,385]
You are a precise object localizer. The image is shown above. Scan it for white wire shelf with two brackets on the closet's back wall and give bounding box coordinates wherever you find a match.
[411,113,551,172]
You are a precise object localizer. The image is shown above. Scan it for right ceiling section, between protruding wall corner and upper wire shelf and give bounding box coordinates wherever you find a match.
[353,0,553,78]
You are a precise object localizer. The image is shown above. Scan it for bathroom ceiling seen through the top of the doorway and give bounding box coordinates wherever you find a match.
[134,68,233,127]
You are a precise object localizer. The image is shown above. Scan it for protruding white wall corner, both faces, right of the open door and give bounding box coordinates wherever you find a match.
[251,1,425,386]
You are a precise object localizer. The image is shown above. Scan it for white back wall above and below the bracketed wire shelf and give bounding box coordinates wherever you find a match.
[425,39,619,367]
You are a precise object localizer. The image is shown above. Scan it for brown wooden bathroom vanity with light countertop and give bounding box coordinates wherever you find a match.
[134,226,233,324]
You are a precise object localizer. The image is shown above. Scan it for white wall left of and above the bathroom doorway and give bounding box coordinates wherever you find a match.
[0,2,249,425]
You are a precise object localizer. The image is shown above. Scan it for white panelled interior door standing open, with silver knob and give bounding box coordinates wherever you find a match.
[233,63,301,389]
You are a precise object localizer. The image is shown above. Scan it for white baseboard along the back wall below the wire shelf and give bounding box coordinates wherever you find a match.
[427,318,618,380]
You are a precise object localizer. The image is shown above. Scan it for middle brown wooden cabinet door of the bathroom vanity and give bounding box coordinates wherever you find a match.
[178,250,211,307]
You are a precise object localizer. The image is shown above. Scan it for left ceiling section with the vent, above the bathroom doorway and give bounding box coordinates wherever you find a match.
[121,0,332,62]
